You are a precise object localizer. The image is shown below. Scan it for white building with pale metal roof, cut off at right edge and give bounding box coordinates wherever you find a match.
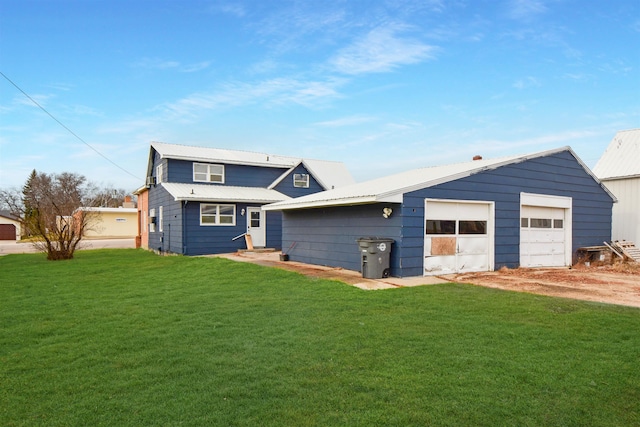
[593,129,640,244]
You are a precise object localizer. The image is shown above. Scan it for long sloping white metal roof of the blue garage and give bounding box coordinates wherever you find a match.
[263,147,615,210]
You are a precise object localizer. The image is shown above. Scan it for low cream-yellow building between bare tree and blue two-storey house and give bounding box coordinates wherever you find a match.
[80,208,138,239]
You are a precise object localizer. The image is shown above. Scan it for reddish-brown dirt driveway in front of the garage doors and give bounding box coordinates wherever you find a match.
[447,263,640,307]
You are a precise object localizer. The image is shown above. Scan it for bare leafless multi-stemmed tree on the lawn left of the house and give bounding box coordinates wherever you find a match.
[0,170,99,260]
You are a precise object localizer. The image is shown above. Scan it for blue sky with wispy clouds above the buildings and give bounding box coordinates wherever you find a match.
[0,0,640,191]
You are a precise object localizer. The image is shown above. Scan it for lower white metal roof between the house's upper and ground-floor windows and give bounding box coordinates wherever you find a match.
[160,182,290,203]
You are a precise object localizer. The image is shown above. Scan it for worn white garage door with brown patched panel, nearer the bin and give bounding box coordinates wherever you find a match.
[424,199,494,275]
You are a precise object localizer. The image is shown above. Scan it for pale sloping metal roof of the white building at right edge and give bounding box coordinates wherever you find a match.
[593,129,640,180]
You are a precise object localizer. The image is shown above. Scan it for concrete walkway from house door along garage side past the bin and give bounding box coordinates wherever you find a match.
[211,251,450,290]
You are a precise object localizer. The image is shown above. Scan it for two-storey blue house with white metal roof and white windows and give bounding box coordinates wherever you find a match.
[138,142,353,255]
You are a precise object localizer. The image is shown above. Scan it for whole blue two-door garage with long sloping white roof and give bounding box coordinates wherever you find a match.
[264,147,615,277]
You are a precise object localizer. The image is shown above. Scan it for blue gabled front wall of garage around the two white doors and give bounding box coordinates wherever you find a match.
[402,152,613,276]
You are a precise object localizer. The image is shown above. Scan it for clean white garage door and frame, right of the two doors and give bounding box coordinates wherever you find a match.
[520,196,571,267]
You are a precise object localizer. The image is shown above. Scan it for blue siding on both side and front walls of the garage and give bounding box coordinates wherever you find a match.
[283,152,612,277]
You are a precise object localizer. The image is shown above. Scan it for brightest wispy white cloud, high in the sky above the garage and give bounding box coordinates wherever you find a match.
[329,26,435,74]
